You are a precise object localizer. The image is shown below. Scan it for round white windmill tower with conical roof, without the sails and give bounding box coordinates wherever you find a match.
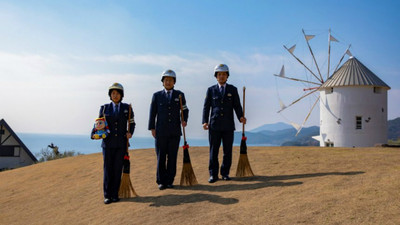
[318,56,390,147]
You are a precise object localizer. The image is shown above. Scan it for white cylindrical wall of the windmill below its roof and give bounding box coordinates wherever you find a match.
[320,86,387,147]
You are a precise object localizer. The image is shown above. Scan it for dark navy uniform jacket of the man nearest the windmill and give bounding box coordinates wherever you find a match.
[203,84,243,131]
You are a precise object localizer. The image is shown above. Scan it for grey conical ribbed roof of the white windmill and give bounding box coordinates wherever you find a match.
[321,57,390,89]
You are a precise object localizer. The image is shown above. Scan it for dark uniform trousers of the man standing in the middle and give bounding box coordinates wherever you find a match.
[155,136,181,185]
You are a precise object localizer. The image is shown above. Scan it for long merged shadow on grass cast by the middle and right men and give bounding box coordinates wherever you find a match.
[176,171,364,192]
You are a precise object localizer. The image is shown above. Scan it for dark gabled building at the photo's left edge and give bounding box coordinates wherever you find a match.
[0,119,37,171]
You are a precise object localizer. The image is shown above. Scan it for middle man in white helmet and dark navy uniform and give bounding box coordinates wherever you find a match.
[148,70,189,190]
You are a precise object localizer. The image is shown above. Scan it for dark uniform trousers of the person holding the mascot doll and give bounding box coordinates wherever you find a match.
[103,148,126,198]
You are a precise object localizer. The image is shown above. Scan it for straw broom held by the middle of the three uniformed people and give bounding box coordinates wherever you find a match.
[179,95,198,186]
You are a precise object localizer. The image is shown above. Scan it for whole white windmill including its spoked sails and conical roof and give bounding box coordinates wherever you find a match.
[274,30,390,147]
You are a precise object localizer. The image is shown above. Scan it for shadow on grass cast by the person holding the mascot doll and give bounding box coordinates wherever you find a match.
[122,193,239,207]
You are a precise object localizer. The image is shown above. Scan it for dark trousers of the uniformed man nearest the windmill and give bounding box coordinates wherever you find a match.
[208,129,233,177]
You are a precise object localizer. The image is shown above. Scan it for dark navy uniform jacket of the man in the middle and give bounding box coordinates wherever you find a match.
[148,89,189,137]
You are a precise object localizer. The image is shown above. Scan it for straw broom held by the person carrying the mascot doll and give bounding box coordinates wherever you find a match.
[118,104,137,198]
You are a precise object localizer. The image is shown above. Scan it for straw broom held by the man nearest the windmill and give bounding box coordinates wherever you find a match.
[236,87,254,177]
